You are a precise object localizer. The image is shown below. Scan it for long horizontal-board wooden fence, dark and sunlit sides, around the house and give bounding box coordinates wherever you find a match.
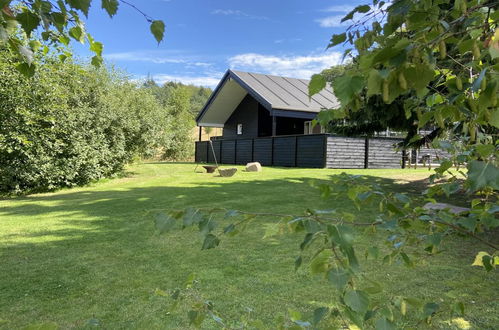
[195,134,405,168]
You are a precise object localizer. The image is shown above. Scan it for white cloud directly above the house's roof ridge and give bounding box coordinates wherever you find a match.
[228,52,342,79]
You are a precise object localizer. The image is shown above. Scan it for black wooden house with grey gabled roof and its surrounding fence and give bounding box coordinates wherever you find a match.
[195,70,410,168]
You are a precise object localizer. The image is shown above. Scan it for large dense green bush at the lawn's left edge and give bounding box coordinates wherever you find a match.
[0,50,167,194]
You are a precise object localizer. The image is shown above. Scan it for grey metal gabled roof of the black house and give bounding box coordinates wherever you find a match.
[196,70,339,124]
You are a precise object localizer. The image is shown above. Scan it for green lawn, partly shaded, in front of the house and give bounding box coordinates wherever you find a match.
[0,163,499,329]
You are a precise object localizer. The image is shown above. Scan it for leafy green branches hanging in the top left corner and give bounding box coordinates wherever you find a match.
[0,0,165,76]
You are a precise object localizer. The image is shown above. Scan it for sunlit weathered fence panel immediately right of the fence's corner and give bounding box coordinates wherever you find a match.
[326,136,366,168]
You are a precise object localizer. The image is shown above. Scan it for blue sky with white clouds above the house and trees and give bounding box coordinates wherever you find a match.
[75,0,367,87]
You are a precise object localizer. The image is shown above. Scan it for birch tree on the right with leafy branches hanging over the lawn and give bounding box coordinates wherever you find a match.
[156,0,499,329]
